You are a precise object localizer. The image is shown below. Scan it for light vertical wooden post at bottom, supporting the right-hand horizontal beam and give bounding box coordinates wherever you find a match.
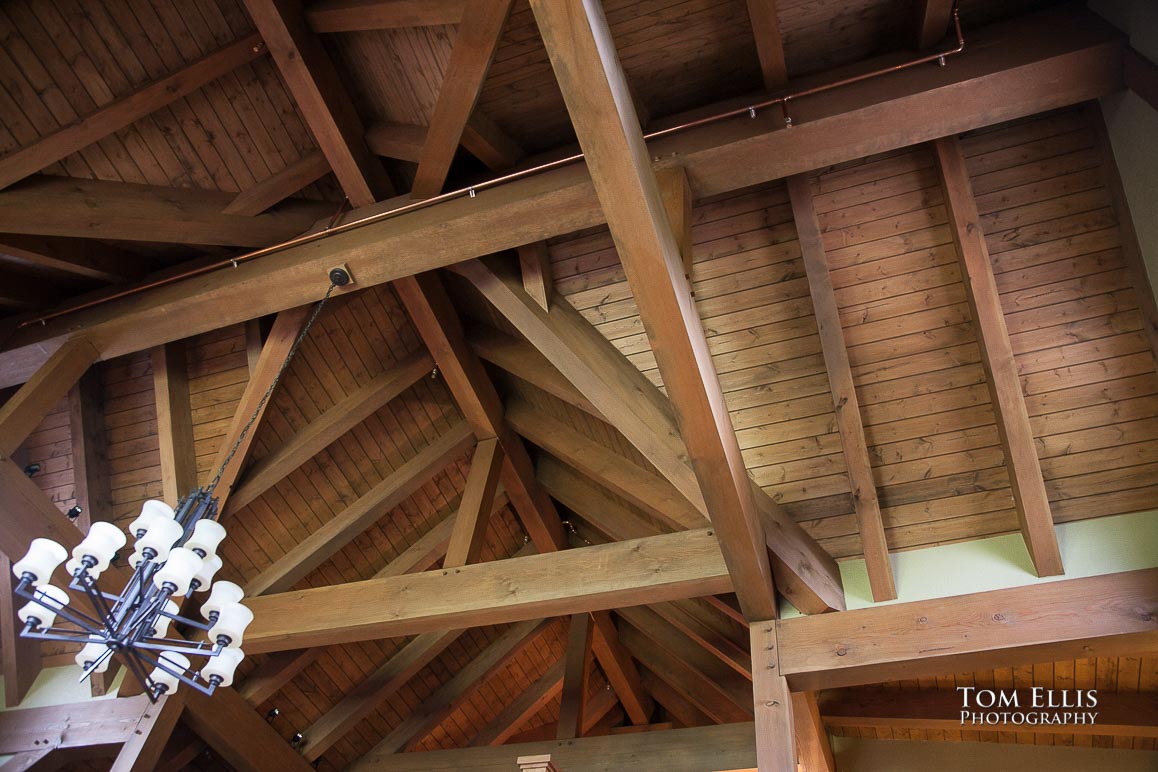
[748,620,797,772]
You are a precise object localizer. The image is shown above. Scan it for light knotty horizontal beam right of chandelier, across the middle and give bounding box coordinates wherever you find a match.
[245,530,732,654]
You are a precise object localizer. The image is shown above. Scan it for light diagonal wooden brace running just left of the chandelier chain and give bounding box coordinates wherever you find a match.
[210,306,313,519]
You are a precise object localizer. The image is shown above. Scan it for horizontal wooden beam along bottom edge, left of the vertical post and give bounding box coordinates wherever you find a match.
[351,722,756,772]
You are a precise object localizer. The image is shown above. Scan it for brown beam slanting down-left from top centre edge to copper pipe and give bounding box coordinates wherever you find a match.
[410,0,514,198]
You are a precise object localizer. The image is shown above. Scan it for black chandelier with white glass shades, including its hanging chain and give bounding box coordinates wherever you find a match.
[12,269,350,703]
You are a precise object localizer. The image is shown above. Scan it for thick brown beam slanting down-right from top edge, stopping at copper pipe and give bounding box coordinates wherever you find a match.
[245,0,394,206]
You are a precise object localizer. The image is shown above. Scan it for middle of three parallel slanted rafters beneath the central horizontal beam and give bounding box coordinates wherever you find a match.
[369,619,551,753]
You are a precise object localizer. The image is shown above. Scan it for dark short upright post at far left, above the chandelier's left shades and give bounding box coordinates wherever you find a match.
[68,368,112,530]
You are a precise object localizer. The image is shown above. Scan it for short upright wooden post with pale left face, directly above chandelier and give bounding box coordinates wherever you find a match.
[152,340,197,506]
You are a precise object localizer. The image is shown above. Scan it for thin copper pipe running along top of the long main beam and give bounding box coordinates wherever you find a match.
[24,2,965,329]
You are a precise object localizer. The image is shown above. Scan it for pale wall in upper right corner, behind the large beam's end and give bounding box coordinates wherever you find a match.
[1089,0,1158,307]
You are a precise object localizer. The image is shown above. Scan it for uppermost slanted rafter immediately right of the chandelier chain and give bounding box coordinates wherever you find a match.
[221,352,434,513]
